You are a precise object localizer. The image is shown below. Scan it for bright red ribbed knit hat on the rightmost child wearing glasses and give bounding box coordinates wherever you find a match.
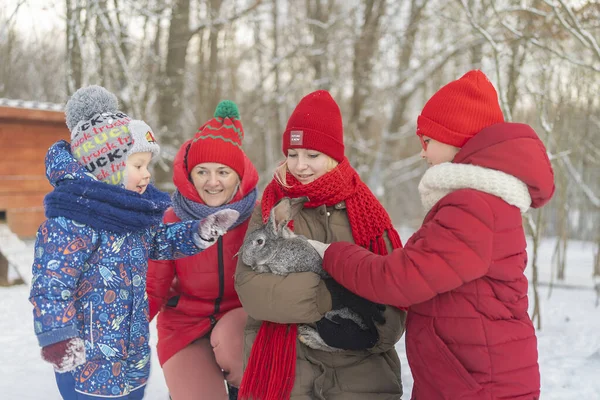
[417,70,504,147]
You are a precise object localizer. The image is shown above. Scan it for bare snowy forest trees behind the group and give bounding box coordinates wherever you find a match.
[0,0,600,318]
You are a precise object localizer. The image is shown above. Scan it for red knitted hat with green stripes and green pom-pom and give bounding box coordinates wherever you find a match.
[186,100,244,177]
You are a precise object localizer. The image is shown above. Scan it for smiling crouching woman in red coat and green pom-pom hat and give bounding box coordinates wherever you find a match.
[147,101,258,400]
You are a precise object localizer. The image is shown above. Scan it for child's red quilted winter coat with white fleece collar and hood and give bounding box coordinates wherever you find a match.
[324,123,554,400]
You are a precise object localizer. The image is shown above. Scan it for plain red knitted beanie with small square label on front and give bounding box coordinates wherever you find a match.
[282,90,344,162]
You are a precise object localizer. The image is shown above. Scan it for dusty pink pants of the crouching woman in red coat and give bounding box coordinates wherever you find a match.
[163,308,247,400]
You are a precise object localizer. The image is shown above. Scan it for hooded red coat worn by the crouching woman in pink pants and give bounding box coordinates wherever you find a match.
[146,140,258,365]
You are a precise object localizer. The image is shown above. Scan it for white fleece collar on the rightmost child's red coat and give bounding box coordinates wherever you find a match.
[419,162,531,213]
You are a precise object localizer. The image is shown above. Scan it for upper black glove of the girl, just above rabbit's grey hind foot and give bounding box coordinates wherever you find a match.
[325,279,385,326]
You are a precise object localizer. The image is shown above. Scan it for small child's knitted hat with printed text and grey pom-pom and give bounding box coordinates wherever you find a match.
[65,85,160,185]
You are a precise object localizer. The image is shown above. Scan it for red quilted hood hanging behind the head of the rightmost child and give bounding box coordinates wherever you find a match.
[453,122,555,208]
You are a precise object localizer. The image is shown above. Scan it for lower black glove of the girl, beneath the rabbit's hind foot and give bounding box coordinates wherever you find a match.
[316,315,379,350]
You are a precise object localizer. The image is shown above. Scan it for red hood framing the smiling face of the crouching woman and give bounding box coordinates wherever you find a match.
[173,138,258,204]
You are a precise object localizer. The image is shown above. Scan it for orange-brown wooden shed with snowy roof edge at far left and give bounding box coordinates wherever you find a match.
[0,99,70,239]
